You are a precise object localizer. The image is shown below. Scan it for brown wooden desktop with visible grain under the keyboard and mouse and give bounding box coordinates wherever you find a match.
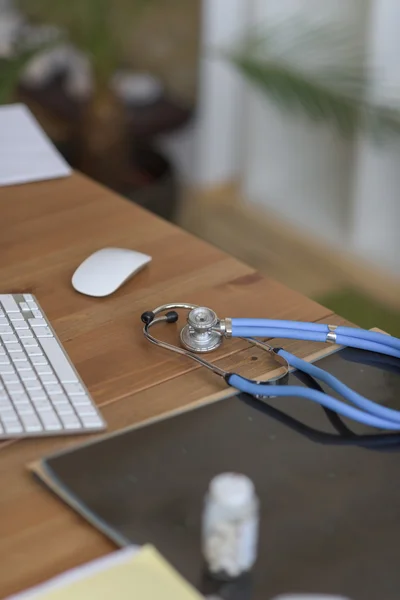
[0,175,344,598]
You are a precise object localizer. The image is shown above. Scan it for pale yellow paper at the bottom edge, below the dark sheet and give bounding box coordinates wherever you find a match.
[15,546,204,600]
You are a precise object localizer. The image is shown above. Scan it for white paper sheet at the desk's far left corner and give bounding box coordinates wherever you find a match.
[0,104,72,186]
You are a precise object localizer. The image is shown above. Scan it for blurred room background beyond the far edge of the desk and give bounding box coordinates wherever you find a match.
[0,0,400,335]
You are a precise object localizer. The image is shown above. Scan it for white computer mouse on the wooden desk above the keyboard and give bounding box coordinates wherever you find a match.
[72,248,151,297]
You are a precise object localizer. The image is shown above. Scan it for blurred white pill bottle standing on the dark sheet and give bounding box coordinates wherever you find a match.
[202,473,259,580]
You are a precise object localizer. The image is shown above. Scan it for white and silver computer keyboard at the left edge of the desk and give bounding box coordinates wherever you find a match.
[0,294,106,439]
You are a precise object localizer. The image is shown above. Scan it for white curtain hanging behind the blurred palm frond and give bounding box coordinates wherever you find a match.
[196,0,400,275]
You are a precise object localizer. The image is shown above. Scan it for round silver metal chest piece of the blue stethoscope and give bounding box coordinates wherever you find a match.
[180,306,223,352]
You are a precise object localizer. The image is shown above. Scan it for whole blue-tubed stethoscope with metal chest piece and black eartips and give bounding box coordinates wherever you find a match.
[141,303,400,431]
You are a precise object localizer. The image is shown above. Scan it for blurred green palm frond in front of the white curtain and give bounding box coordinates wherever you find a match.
[223,17,400,139]
